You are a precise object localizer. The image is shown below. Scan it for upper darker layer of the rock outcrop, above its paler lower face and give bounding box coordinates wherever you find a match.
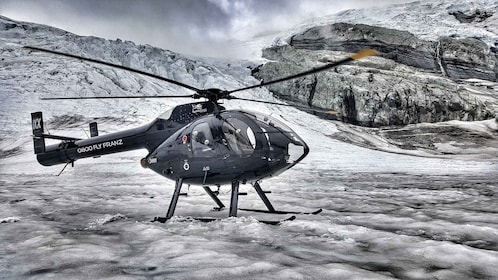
[288,23,498,81]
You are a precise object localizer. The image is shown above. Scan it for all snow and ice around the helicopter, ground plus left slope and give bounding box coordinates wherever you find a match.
[0,5,498,279]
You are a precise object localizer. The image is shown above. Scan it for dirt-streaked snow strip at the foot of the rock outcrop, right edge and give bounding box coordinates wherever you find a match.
[332,117,498,159]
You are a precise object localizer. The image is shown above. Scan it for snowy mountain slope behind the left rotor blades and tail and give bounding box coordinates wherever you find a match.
[0,15,286,145]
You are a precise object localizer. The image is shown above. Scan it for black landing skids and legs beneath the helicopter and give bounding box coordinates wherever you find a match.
[153,178,322,225]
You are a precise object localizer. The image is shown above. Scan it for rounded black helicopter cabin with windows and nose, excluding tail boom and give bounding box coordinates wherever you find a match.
[145,110,309,185]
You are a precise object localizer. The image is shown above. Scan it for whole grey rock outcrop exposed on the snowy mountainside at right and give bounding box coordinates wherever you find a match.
[253,23,498,126]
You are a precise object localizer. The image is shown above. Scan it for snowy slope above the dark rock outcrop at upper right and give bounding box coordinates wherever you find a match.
[273,0,498,46]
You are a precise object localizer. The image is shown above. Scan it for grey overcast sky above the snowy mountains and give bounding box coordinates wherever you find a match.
[0,0,411,57]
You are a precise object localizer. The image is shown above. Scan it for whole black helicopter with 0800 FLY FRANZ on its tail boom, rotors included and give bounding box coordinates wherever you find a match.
[25,46,376,222]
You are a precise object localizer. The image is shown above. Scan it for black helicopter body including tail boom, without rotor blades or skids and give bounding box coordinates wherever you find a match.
[33,102,309,185]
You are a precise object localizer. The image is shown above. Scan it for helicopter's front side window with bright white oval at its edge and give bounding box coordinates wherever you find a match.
[223,118,256,155]
